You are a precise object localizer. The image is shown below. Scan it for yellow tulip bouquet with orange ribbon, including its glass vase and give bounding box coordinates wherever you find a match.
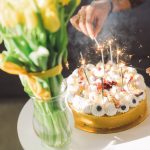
[0,0,80,147]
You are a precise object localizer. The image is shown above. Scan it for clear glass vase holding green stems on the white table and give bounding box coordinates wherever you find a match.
[32,88,71,149]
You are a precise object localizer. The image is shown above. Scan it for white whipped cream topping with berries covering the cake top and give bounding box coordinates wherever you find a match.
[67,62,146,117]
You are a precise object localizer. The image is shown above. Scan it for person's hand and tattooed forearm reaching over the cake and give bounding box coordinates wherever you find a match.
[70,0,144,38]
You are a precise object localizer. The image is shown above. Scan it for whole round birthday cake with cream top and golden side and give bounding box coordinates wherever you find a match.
[67,62,147,133]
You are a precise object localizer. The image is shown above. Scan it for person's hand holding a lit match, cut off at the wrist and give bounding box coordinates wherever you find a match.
[70,1,111,39]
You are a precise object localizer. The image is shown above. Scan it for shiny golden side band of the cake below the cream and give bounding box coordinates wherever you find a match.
[70,88,150,134]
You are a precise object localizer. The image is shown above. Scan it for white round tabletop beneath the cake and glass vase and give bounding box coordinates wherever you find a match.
[17,89,150,150]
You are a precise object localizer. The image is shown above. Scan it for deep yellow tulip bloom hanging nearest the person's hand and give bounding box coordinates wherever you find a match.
[41,5,60,32]
